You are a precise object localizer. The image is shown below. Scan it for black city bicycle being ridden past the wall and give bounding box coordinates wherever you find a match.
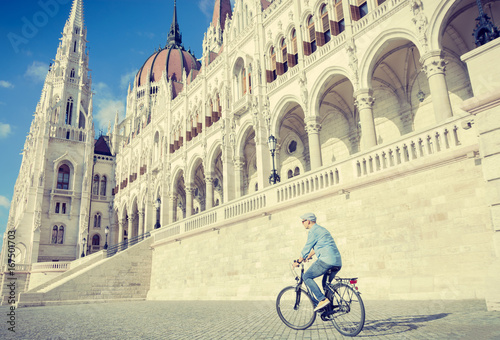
[276,262,365,336]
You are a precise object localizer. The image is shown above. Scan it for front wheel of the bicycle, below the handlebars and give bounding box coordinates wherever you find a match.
[276,286,316,330]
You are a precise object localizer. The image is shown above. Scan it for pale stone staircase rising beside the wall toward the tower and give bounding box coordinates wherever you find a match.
[17,238,153,307]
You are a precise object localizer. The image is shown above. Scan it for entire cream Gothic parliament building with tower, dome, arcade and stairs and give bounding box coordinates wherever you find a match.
[0,0,500,310]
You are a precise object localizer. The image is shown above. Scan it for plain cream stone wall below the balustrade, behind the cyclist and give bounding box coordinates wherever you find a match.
[148,146,493,300]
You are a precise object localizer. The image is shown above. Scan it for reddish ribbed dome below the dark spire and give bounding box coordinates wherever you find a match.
[135,45,201,86]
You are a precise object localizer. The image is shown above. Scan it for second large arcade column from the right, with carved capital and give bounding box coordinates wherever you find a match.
[354,89,377,150]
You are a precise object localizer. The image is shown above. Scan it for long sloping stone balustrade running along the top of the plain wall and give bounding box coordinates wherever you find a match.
[151,117,478,244]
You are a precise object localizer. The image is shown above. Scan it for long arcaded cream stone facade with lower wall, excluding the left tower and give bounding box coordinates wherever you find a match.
[0,0,500,308]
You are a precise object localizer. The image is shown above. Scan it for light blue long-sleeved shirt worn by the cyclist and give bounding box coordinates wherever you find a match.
[301,223,342,267]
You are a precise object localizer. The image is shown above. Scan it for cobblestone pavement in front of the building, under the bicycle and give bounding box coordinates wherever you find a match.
[0,301,500,340]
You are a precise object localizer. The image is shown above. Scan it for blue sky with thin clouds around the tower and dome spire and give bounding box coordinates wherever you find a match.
[0,0,233,247]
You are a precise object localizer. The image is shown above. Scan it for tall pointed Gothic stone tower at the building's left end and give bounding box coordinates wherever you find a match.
[2,0,94,264]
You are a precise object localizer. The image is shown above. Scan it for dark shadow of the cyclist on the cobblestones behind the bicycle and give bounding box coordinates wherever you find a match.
[358,313,450,337]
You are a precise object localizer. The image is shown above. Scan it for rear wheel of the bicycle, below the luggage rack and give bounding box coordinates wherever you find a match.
[331,283,365,336]
